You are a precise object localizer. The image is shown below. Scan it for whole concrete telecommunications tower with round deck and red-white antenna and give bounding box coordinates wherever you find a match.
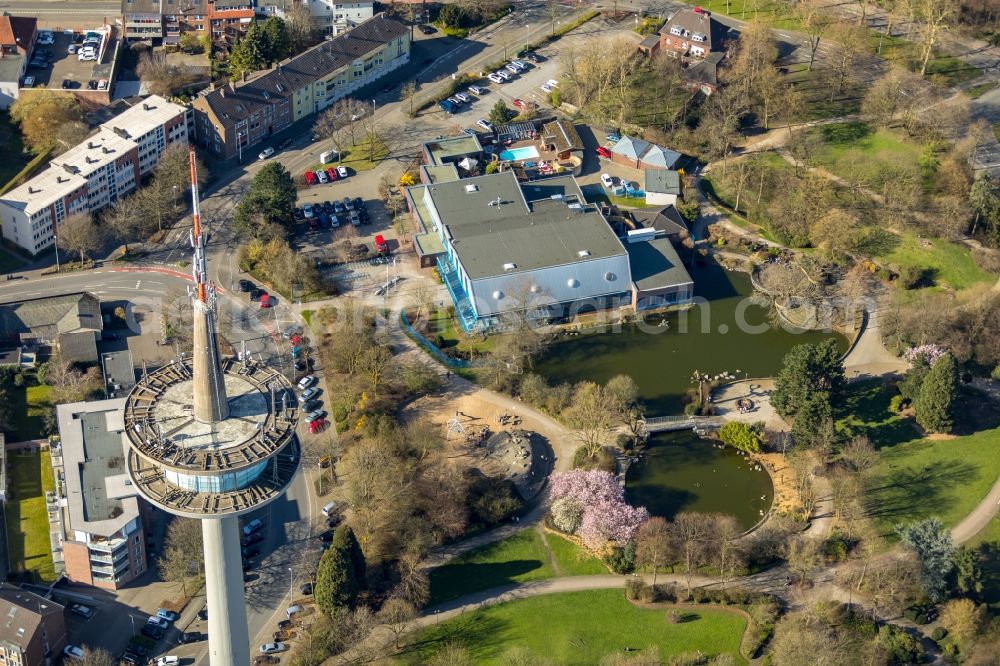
[125,149,299,666]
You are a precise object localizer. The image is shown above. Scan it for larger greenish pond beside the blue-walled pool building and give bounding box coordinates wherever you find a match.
[534,261,847,416]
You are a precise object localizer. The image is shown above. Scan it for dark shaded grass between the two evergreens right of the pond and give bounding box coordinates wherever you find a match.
[835,379,918,448]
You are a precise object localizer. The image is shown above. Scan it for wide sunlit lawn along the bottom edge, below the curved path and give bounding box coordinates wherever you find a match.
[397,589,746,664]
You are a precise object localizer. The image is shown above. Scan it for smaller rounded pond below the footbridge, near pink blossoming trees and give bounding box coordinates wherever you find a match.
[625,430,774,530]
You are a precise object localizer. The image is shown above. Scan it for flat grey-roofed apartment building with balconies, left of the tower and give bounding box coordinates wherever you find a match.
[52,398,148,590]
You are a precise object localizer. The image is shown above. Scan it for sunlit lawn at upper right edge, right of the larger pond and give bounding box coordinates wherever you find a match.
[880,233,996,289]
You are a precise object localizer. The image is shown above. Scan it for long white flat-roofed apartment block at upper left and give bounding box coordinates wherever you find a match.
[0,95,191,254]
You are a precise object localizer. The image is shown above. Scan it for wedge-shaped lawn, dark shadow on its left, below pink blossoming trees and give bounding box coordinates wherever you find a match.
[428,529,608,606]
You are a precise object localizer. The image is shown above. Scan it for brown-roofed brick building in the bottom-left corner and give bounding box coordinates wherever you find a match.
[0,583,66,666]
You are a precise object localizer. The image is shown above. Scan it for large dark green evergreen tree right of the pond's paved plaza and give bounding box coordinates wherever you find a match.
[771,340,844,418]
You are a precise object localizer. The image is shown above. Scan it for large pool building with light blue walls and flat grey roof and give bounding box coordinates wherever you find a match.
[406,171,690,331]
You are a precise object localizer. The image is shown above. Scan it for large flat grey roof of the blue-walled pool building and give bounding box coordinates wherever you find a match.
[428,171,625,280]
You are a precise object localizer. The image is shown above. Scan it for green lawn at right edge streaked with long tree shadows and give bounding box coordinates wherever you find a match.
[865,428,1000,538]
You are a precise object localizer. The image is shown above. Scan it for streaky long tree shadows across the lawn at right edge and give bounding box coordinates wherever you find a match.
[865,461,977,520]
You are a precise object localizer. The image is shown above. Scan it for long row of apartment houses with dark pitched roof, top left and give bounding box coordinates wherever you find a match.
[192,14,410,159]
